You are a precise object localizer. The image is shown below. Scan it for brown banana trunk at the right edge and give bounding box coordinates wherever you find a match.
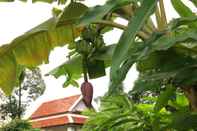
[183,86,197,112]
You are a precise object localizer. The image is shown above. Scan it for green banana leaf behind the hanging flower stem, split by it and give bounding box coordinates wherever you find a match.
[47,45,115,87]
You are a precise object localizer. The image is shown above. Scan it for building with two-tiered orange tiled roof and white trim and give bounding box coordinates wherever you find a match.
[30,95,87,131]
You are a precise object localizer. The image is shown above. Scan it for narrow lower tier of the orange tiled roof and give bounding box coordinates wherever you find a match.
[32,115,87,128]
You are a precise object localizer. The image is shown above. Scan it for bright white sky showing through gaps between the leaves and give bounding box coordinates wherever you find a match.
[0,0,196,116]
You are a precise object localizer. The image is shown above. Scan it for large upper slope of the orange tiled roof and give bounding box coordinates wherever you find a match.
[30,95,80,119]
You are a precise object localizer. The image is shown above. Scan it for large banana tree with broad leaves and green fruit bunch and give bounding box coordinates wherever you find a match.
[0,0,197,124]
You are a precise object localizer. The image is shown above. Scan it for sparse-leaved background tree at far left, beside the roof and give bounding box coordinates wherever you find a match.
[0,68,45,120]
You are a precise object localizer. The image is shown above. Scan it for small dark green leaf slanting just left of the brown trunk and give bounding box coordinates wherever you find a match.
[154,85,176,112]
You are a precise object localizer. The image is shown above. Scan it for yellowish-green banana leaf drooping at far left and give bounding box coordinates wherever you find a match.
[0,3,85,94]
